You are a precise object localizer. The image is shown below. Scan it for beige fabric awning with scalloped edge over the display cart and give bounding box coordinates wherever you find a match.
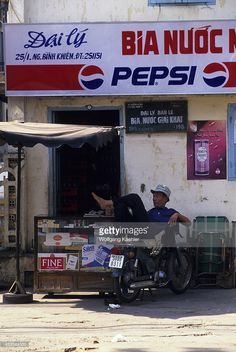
[0,121,117,148]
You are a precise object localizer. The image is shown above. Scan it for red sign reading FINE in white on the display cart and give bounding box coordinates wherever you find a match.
[38,253,67,270]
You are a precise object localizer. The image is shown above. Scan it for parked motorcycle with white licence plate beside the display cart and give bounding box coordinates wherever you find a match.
[109,229,193,303]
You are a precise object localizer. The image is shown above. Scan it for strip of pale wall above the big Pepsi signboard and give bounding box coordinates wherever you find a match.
[20,0,235,23]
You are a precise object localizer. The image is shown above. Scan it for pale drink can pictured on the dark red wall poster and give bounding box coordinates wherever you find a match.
[194,139,209,176]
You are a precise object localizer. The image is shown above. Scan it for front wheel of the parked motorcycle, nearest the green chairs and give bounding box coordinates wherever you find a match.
[168,250,193,294]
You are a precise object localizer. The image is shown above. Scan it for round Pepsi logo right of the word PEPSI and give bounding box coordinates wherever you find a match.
[203,62,229,87]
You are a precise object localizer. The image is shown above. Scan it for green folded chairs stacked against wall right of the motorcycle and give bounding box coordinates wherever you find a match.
[192,216,232,286]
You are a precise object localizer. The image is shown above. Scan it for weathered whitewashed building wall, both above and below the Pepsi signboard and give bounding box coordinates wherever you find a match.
[6,0,236,248]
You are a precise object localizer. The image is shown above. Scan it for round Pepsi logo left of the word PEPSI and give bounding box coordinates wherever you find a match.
[78,65,104,90]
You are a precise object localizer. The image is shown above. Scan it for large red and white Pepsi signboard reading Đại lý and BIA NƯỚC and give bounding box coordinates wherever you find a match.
[4,20,236,96]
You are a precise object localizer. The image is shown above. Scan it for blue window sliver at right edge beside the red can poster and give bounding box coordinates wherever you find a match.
[227,104,236,181]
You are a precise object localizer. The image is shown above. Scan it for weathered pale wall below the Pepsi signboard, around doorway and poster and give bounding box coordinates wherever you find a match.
[6,95,236,249]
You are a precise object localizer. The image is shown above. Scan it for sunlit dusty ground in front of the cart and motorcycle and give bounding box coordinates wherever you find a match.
[0,288,236,352]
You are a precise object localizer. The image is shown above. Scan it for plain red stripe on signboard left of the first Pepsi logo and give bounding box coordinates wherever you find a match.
[6,65,85,91]
